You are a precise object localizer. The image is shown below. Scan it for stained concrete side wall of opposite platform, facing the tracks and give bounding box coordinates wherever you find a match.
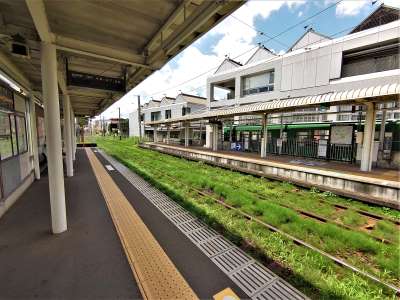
[141,143,400,209]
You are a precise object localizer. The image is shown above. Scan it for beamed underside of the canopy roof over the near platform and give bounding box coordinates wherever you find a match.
[0,0,244,116]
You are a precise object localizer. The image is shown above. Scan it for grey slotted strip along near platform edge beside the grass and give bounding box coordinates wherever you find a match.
[98,150,307,300]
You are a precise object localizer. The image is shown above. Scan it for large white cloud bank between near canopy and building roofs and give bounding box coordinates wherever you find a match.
[101,0,305,118]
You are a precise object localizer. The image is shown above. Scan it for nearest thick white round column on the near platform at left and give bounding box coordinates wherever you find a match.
[41,42,67,233]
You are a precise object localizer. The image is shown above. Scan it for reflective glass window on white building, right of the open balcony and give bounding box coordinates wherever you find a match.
[243,71,275,96]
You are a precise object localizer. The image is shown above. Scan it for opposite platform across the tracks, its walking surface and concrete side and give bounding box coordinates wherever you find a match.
[141,142,400,209]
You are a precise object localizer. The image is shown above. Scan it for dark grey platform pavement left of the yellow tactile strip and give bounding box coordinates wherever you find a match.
[0,150,141,299]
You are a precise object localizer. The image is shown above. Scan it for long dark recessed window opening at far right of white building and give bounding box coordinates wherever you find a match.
[342,40,399,77]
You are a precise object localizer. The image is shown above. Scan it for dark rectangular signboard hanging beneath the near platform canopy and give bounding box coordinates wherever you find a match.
[67,70,125,93]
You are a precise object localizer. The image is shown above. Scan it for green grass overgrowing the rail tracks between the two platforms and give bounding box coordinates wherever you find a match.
[96,137,400,299]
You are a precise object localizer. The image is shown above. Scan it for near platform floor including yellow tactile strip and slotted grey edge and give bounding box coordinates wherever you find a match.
[0,148,305,299]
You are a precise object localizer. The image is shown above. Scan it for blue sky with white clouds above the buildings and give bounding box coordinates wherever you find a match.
[101,0,400,118]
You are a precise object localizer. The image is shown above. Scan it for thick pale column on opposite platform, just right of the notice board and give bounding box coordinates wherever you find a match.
[360,102,376,172]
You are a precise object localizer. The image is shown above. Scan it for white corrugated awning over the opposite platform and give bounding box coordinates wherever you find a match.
[145,83,400,125]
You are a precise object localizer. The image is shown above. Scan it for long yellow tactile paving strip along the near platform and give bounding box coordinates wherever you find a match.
[86,148,198,299]
